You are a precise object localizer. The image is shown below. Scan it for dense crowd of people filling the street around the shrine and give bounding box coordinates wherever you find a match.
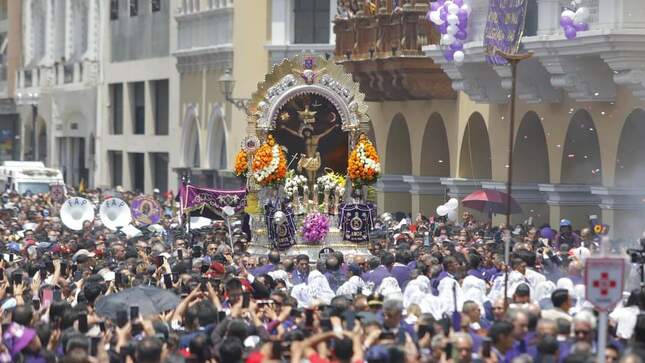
[0,191,645,363]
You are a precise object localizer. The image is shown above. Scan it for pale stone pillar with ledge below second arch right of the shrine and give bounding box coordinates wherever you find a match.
[403,175,446,219]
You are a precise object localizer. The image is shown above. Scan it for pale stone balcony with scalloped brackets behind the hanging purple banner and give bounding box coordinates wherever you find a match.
[423,0,645,103]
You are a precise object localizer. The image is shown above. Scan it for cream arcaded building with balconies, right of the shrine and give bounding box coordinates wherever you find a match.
[335,0,645,240]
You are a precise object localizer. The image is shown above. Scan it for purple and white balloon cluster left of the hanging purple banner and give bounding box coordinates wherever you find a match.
[426,0,472,63]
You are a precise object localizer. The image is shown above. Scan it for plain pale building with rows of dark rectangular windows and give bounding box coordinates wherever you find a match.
[96,0,181,194]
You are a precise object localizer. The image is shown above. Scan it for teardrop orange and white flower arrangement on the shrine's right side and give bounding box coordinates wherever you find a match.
[347,134,381,185]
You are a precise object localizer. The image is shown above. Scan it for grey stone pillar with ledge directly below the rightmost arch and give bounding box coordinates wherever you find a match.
[591,187,645,241]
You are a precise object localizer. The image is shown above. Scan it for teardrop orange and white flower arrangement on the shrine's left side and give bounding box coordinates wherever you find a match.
[253,135,287,186]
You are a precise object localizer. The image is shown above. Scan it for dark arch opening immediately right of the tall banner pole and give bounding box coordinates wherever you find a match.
[513,111,549,183]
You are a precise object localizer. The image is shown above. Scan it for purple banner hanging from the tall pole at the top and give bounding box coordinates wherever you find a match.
[484,0,528,65]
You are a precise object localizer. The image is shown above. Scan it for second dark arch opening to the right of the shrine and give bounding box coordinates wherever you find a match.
[421,113,450,177]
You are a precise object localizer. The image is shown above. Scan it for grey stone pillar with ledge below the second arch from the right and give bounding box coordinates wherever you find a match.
[539,184,600,229]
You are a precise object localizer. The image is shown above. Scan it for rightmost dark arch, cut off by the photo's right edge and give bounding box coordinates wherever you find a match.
[614,108,645,187]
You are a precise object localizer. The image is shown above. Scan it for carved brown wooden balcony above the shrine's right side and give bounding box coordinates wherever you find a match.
[334,0,456,101]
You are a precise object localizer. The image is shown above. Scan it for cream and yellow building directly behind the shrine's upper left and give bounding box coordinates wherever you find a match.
[173,0,336,186]
